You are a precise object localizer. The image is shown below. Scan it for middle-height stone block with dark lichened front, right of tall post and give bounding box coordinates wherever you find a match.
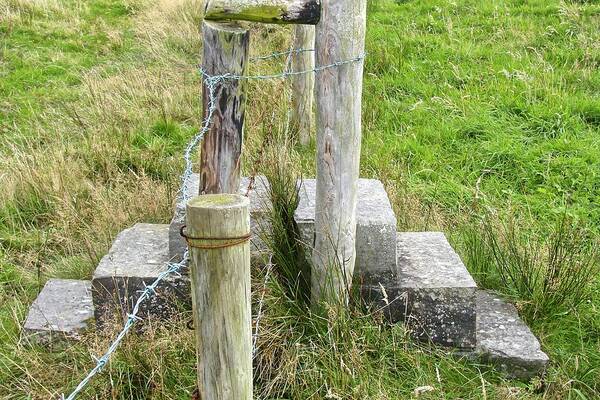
[362,232,476,349]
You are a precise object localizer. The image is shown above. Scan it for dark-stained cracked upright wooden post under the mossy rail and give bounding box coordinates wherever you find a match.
[200,21,250,194]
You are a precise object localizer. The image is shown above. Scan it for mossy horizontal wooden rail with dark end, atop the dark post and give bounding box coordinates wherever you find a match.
[204,0,321,25]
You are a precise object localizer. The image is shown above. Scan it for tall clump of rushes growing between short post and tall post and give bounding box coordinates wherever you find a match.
[259,125,310,305]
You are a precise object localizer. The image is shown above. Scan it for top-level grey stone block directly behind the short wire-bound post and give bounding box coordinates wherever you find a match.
[169,174,271,261]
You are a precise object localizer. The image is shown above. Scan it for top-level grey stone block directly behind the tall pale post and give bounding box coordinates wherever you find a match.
[294,178,396,285]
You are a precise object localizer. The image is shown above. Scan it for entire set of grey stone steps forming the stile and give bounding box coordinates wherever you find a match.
[23,175,548,378]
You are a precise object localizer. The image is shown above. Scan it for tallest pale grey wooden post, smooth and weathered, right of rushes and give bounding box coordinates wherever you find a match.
[311,0,367,304]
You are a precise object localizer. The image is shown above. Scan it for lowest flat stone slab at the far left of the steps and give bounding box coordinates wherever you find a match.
[22,279,94,344]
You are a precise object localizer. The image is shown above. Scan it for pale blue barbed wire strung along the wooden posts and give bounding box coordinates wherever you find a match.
[61,49,366,400]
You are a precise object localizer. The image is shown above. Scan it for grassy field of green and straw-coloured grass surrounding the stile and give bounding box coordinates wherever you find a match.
[0,0,600,399]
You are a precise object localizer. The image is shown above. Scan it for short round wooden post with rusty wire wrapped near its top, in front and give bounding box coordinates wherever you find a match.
[183,194,252,400]
